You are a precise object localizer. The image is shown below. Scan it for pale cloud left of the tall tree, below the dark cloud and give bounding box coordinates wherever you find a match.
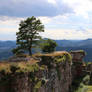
[0,16,20,40]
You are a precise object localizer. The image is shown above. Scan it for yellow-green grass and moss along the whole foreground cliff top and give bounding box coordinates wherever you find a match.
[0,51,72,74]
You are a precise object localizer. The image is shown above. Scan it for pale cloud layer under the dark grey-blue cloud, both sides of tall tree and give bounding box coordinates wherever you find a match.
[0,14,92,40]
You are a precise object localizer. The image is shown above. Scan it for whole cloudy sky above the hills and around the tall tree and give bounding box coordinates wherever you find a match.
[0,0,92,40]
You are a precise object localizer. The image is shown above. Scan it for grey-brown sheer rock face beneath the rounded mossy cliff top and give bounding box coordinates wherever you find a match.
[38,51,72,92]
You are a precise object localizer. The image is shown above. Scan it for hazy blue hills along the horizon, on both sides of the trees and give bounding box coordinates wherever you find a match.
[0,39,92,61]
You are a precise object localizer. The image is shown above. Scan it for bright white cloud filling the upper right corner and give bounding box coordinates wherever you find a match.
[63,0,92,18]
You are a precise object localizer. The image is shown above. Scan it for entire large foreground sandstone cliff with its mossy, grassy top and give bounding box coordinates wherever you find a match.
[0,52,72,92]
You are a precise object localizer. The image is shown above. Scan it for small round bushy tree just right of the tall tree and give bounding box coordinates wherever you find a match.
[41,39,57,53]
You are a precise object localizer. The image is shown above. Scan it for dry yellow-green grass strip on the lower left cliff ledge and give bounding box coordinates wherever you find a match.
[0,59,39,74]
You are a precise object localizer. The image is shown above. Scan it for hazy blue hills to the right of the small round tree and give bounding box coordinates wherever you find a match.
[56,39,92,61]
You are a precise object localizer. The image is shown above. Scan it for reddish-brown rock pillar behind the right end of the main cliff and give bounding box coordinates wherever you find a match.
[70,50,86,78]
